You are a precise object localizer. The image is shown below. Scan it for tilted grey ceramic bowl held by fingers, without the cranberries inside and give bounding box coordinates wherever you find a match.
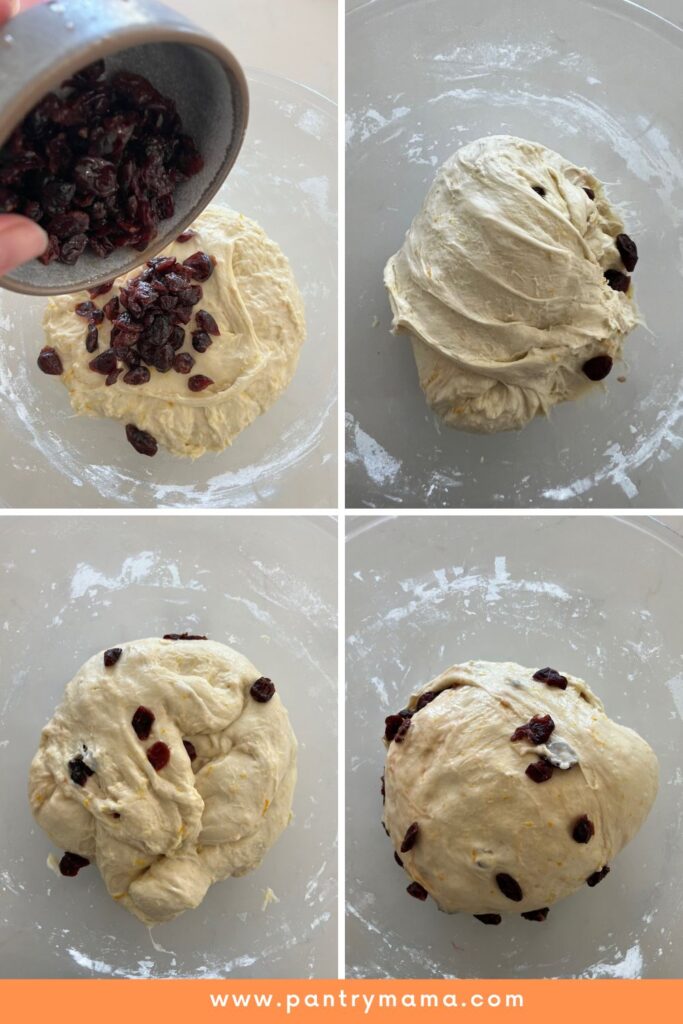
[0,0,249,295]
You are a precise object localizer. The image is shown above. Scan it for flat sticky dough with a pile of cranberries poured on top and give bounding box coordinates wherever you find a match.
[43,206,305,458]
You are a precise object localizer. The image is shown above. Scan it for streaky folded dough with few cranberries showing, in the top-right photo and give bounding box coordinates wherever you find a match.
[384,135,639,433]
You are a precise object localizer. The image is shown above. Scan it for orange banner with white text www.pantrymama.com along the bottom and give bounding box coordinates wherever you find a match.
[0,979,683,1024]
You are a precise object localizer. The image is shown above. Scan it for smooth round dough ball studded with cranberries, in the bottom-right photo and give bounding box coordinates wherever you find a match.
[384,662,657,924]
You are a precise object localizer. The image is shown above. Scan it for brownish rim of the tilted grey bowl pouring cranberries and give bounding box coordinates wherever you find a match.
[0,18,249,296]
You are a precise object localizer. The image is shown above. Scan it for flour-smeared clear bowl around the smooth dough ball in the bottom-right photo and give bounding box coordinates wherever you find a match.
[346,516,683,978]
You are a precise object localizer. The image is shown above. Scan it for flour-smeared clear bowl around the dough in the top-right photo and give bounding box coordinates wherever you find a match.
[346,0,683,508]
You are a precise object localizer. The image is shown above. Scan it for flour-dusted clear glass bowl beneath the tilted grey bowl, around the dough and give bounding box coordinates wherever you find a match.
[0,72,337,508]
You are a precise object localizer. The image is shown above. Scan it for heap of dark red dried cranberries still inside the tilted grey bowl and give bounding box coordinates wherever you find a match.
[0,60,204,266]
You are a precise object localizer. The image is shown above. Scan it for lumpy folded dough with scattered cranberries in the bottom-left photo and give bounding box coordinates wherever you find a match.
[29,637,297,925]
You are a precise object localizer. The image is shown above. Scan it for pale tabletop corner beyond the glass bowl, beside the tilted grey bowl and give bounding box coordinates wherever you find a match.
[164,0,337,100]
